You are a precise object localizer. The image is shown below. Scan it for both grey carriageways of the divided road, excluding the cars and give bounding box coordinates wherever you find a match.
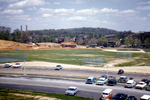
[0,67,150,99]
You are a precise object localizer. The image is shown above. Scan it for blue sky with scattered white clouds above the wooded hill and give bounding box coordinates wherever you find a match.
[0,0,150,32]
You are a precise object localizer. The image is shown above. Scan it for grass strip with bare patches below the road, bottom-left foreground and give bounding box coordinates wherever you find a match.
[0,88,95,100]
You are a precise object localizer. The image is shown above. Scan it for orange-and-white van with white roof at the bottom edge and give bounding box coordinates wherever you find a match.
[99,89,113,100]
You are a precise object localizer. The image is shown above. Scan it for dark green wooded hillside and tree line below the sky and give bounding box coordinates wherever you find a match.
[0,26,150,48]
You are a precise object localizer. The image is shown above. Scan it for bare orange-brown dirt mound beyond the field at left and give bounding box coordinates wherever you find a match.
[0,40,60,50]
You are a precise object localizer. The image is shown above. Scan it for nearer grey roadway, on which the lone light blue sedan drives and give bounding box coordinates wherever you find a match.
[0,75,150,100]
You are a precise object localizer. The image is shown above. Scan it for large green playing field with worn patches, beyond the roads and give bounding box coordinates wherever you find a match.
[0,49,150,66]
